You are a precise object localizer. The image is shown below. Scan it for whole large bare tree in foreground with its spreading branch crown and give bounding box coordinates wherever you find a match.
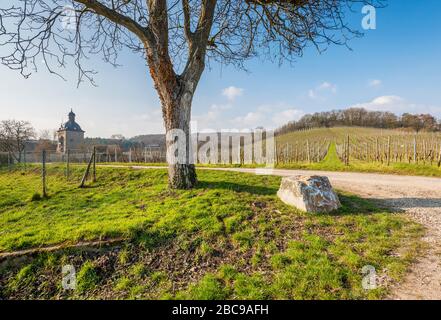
[0,0,381,188]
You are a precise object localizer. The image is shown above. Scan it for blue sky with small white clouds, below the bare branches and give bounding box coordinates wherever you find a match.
[0,0,441,137]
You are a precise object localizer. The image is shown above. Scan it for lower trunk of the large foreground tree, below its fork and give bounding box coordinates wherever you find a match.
[164,85,197,189]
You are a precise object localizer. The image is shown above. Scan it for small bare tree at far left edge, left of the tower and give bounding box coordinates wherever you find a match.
[0,120,35,162]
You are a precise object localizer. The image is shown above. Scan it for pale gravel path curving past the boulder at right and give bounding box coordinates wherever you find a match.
[127,167,441,300]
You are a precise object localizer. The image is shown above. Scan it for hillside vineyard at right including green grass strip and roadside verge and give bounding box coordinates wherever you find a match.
[277,127,441,176]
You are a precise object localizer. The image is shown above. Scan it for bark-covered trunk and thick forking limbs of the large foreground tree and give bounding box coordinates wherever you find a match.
[141,0,216,189]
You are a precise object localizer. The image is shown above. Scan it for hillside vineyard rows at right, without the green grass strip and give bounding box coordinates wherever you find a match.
[277,127,441,166]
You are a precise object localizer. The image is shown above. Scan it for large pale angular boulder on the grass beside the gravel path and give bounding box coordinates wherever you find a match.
[277,176,341,212]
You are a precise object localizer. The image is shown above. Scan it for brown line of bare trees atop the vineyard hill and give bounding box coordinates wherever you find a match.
[276,108,441,134]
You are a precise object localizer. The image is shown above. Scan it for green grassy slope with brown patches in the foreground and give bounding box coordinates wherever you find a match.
[0,168,422,299]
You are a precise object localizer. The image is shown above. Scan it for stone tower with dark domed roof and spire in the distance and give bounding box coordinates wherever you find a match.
[57,109,84,153]
